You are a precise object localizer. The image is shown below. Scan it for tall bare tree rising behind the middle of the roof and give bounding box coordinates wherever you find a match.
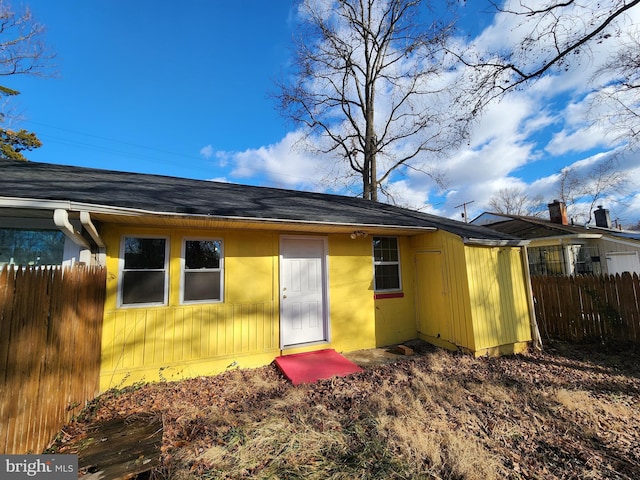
[277,0,466,201]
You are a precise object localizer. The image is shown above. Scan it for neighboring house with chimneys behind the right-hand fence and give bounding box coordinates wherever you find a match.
[471,200,640,275]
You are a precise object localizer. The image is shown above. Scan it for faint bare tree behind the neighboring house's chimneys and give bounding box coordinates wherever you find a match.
[558,156,629,224]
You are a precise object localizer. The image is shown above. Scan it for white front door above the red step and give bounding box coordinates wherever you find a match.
[280,237,328,347]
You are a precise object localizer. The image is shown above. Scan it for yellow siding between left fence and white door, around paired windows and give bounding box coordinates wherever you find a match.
[100,226,279,390]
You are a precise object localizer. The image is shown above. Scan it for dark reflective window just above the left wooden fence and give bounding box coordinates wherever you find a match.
[0,228,65,266]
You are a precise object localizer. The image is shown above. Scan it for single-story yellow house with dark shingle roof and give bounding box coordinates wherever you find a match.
[0,161,533,390]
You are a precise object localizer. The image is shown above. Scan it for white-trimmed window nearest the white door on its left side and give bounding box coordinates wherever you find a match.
[181,239,224,303]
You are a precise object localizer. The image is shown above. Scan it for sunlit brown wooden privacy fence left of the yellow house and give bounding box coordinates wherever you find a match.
[0,266,106,454]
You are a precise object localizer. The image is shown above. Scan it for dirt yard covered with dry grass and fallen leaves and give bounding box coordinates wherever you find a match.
[48,342,640,480]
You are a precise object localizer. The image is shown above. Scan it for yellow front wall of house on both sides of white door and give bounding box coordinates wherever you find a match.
[100,225,390,391]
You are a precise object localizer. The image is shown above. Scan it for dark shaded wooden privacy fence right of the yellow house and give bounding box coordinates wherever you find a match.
[531,273,640,344]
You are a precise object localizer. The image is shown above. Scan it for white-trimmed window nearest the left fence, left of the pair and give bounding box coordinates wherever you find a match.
[120,237,169,305]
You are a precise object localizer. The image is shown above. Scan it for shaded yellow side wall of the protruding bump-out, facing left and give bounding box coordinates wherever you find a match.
[412,231,474,350]
